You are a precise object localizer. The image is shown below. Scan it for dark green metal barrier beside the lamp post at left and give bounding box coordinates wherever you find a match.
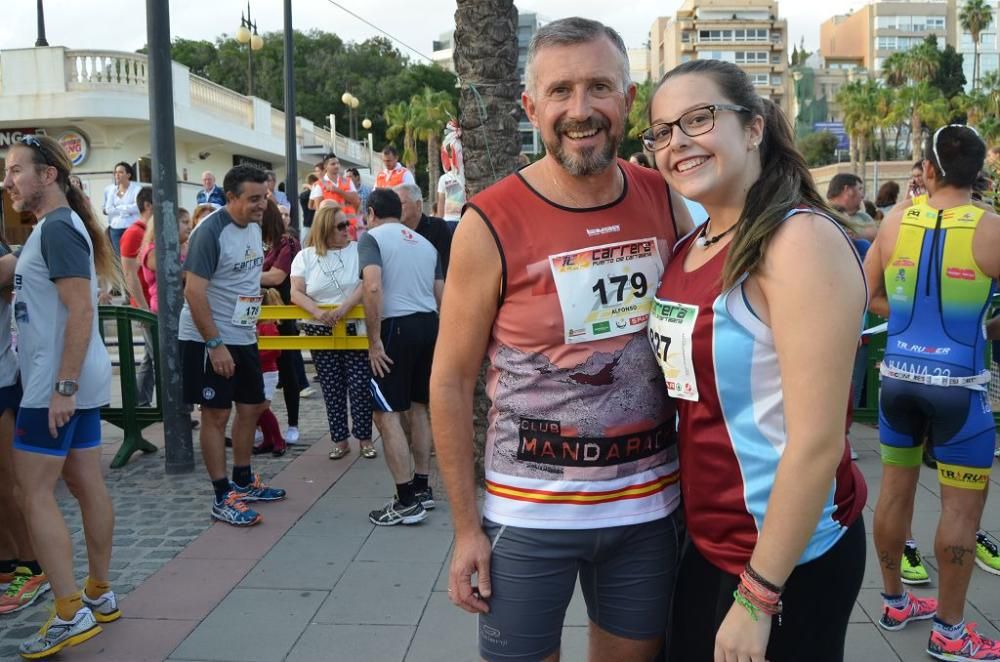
[97,306,163,469]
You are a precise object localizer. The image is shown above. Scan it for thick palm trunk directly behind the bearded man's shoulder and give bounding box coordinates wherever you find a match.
[454,0,521,195]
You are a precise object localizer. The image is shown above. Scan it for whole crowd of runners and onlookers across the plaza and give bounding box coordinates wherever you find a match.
[0,10,1000,662]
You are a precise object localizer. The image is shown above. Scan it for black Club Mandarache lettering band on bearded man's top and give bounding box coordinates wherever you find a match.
[517,418,676,467]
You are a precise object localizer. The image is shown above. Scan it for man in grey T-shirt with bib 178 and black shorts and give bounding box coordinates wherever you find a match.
[178,166,285,526]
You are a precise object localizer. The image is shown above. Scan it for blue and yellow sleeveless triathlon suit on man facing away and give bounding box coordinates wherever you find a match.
[879,199,996,489]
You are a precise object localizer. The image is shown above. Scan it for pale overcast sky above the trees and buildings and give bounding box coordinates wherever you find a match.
[0,0,864,57]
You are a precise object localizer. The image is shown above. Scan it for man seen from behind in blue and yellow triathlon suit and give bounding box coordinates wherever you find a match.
[866,125,1000,660]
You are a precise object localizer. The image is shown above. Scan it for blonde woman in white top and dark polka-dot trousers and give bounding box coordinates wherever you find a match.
[291,202,377,460]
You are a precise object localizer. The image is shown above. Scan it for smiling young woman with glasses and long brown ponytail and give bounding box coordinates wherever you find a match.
[642,60,866,662]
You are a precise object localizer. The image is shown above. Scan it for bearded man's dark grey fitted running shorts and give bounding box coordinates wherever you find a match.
[479,511,684,662]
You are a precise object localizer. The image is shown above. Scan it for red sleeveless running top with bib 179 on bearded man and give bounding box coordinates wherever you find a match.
[469,161,680,529]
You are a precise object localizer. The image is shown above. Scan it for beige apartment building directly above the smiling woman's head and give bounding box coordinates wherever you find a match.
[649,0,792,114]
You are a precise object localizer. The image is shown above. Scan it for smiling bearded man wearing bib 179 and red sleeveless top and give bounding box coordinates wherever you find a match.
[431,18,690,661]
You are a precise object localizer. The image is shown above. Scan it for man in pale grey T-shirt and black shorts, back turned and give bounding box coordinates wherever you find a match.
[358,189,444,526]
